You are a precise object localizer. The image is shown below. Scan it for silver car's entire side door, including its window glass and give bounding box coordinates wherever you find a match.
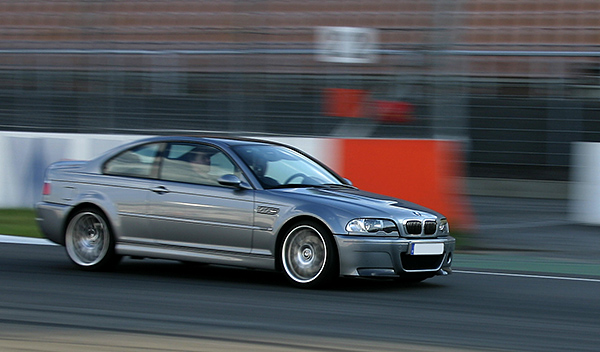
[148,142,254,253]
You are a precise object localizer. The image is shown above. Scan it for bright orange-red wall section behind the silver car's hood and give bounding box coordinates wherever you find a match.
[338,139,473,230]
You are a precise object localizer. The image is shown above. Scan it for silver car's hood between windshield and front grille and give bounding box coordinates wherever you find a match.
[279,187,444,218]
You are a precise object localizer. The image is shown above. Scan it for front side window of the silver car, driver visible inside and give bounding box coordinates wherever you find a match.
[159,143,244,186]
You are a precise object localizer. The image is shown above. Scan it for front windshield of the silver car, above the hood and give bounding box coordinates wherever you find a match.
[233,145,344,188]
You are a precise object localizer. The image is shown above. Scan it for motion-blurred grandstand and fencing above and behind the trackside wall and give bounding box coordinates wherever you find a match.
[0,0,600,187]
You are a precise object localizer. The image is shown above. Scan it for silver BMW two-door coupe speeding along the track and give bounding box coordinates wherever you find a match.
[36,137,455,287]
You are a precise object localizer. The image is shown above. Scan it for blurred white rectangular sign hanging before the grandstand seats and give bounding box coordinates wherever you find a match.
[316,27,379,64]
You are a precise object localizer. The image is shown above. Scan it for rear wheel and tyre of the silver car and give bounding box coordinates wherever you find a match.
[65,208,121,270]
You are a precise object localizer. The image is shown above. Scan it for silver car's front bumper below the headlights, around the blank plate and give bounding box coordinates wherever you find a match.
[334,235,456,277]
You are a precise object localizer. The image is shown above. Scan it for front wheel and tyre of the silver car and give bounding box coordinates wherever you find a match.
[280,221,339,288]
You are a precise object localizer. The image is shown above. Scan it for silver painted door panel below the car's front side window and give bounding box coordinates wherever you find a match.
[147,182,255,253]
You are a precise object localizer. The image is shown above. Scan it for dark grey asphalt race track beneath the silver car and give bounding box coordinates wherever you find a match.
[0,239,600,351]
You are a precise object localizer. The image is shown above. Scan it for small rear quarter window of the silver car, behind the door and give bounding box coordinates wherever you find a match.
[104,143,160,177]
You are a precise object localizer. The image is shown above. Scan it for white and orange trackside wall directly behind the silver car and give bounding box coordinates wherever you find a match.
[0,132,472,227]
